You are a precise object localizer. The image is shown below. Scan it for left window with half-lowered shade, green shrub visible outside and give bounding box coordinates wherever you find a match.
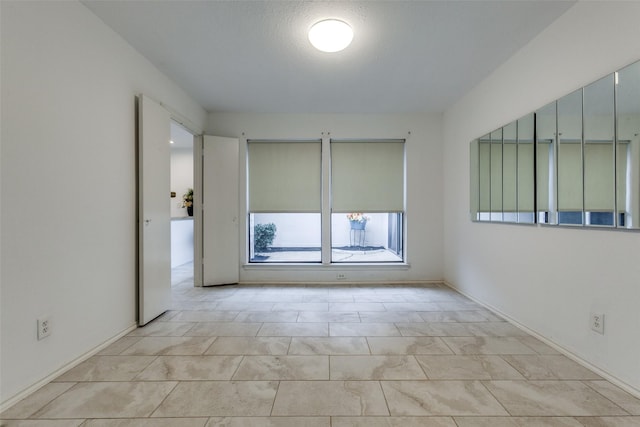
[247,140,322,262]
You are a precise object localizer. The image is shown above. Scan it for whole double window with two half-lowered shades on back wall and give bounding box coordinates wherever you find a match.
[247,139,404,264]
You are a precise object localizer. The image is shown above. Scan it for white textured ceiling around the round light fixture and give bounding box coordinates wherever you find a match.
[83,0,575,113]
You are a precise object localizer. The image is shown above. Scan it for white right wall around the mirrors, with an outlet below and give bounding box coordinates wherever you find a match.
[443,2,640,391]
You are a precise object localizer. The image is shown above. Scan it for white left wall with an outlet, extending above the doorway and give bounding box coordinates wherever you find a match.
[0,1,206,403]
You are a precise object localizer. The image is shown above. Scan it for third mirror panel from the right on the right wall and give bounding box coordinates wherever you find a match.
[557,89,584,225]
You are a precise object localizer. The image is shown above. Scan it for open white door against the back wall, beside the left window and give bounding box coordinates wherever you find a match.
[201,135,240,286]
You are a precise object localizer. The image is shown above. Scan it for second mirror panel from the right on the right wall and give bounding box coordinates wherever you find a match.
[583,74,616,227]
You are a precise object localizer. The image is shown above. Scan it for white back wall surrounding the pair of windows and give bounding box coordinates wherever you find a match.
[207,113,443,282]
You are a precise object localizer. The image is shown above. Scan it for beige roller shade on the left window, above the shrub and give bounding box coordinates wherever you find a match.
[247,140,322,213]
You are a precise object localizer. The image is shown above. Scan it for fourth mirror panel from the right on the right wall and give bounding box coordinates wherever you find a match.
[536,101,557,224]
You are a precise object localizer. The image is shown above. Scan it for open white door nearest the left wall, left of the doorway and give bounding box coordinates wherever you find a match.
[138,96,171,326]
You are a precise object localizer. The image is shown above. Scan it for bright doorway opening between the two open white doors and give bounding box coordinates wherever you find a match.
[170,121,194,287]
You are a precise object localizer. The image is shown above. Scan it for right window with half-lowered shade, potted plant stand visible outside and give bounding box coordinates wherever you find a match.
[331,140,404,262]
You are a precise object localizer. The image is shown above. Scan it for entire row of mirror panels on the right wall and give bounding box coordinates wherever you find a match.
[470,61,640,229]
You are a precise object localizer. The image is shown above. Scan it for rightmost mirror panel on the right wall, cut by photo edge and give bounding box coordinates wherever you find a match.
[615,61,640,229]
